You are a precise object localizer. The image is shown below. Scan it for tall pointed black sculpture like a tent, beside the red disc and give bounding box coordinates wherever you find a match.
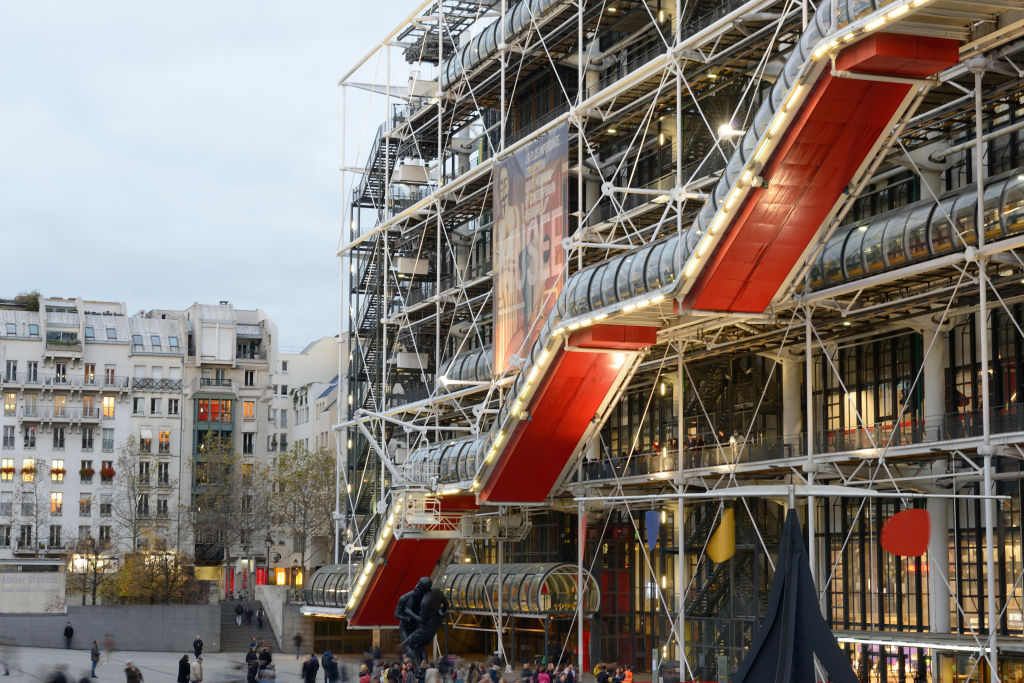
[732,510,857,683]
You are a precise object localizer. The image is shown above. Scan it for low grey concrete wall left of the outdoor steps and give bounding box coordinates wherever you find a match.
[0,604,220,653]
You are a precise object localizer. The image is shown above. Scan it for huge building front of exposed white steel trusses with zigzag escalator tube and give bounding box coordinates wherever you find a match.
[334,0,1024,681]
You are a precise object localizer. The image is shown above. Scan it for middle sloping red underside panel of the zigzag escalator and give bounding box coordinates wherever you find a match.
[480,351,629,503]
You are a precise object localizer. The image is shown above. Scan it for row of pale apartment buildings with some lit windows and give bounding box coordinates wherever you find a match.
[0,296,338,588]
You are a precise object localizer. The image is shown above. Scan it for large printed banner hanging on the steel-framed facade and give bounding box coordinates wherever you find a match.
[493,124,569,374]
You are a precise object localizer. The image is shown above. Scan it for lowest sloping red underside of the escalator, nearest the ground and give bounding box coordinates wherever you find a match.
[348,539,449,627]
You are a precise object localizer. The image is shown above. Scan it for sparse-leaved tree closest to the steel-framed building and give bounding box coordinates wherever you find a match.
[271,441,335,577]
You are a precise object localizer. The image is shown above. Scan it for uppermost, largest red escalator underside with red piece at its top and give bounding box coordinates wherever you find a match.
[684,34,958,312]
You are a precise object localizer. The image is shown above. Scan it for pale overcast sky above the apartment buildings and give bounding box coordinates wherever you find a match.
[0,0,418,346]
